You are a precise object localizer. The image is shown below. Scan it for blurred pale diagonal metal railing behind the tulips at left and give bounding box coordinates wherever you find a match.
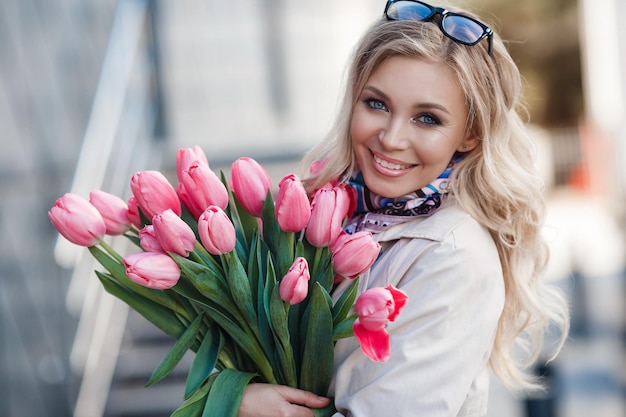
[55,0,164,417]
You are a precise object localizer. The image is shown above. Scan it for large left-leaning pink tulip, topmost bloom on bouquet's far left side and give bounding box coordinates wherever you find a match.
[130,171,182,220]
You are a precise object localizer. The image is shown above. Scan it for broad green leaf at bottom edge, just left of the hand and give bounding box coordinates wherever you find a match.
[202,368,255,417]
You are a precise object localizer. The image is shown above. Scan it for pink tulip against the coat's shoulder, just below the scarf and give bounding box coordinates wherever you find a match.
[330,232,380,278]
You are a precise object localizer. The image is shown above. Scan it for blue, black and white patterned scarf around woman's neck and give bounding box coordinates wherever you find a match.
[346,156,461,233]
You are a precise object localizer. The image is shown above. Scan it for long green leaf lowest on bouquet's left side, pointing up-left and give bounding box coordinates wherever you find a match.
[96,271,185,339]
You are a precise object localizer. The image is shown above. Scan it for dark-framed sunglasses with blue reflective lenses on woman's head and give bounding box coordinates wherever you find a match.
[385,0,493,55]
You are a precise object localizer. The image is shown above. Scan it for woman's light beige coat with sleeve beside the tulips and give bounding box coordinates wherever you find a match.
[330,199,504,417]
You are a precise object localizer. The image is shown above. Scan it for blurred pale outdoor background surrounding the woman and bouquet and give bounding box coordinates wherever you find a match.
[0,0,626,417]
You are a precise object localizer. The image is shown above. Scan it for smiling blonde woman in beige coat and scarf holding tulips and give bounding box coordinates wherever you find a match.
[239,0,569,417]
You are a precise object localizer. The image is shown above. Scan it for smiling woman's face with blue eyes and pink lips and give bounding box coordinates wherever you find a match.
[350,56,478,198]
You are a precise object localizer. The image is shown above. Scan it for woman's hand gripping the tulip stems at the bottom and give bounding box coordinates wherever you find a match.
[239,384,329,417]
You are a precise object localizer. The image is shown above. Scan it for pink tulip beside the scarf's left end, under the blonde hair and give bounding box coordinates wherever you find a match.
[305,186,351,247]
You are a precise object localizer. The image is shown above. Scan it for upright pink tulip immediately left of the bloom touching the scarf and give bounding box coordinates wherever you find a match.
[274,174,311,232]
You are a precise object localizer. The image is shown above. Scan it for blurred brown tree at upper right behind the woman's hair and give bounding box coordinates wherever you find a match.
[472,0,583,127]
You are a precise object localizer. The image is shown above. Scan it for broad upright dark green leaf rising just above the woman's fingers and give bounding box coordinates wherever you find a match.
[300,283,334,395]
